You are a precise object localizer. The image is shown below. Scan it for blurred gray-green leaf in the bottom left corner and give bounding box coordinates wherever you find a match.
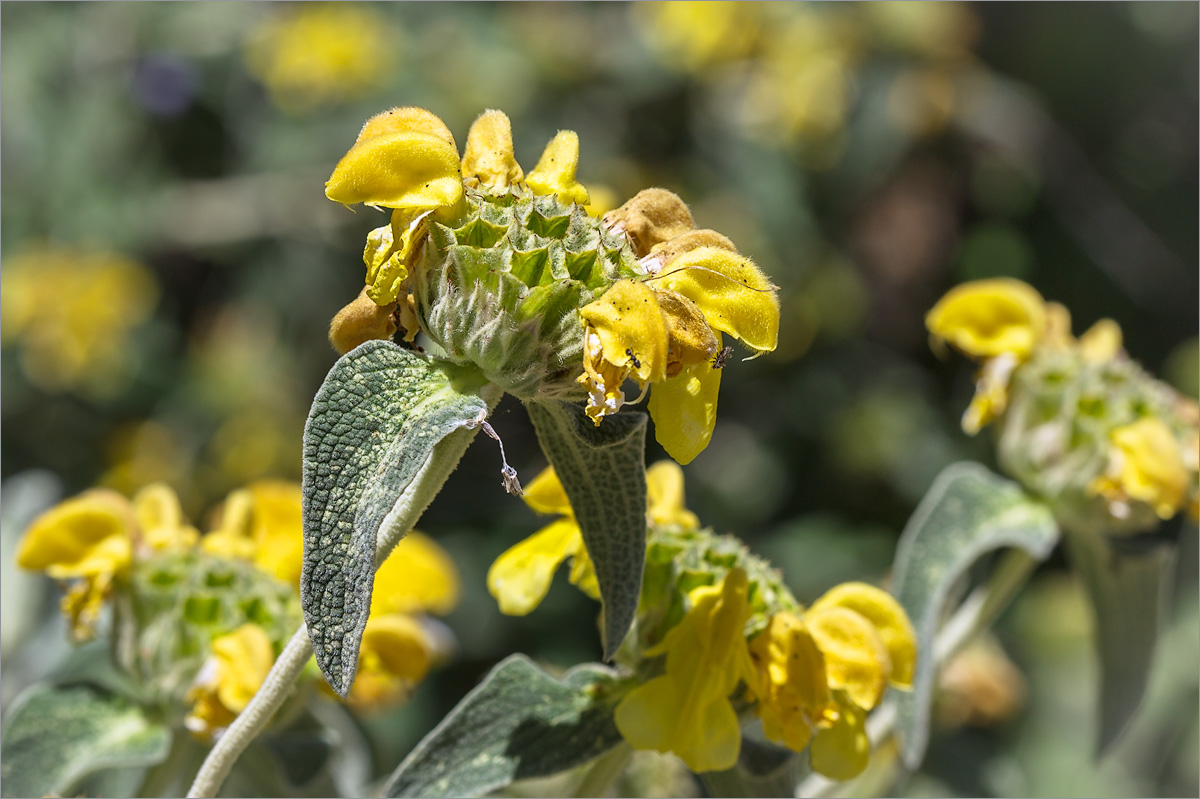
[0,684,170,797]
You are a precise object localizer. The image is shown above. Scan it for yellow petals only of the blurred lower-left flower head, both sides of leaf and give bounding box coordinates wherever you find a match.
[17,481,458,738]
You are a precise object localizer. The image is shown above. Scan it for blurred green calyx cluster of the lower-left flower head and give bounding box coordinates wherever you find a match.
[114,551,301,714]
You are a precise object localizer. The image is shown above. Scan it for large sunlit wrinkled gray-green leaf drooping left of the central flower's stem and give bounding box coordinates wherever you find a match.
[300,341,488,696]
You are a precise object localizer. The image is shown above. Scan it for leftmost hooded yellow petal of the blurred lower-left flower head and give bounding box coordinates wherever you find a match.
[17,489,133,579]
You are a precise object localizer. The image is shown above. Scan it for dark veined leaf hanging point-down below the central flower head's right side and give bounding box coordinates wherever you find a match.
[526,402,646,659]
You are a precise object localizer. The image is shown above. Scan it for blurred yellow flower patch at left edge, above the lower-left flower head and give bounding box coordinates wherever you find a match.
[0,248,158,398]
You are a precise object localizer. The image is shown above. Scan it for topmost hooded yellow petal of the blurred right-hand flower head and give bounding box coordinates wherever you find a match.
[925,277,1046,360]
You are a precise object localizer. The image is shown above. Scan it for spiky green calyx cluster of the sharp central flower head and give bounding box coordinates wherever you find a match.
[410,190,641,400]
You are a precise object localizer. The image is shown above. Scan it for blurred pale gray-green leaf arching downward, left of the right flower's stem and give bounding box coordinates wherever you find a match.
[893,463,1058,768]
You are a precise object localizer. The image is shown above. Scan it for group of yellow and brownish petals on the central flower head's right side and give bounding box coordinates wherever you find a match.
[580,199,779,463]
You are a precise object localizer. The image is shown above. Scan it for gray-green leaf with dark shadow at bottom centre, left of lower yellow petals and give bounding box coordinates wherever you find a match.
[384,655,622,797]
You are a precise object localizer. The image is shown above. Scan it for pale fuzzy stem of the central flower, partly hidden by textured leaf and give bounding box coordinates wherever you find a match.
[187,417,498,797]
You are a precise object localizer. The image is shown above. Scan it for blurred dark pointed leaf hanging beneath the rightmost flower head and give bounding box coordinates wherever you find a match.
[1063,529,1175,757]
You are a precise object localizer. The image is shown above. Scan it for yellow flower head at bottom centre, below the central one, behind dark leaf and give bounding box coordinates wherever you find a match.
[488,462,916,779]
